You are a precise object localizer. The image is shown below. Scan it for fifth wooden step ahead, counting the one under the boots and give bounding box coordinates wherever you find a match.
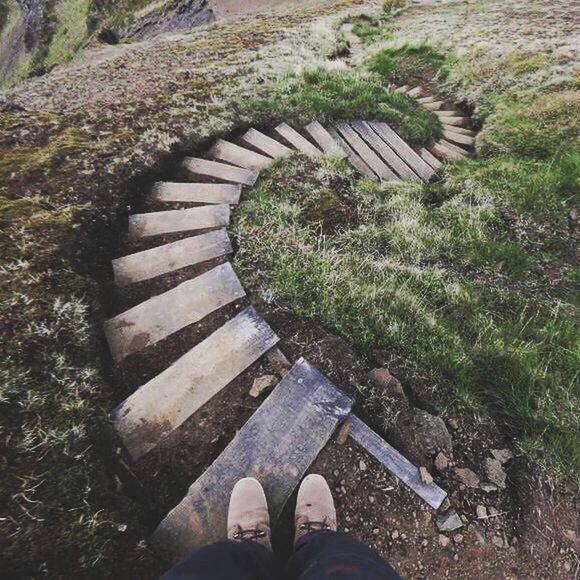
[129,204,230,239]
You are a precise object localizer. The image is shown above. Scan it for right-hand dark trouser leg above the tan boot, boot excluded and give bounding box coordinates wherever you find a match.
[287,531,400,580]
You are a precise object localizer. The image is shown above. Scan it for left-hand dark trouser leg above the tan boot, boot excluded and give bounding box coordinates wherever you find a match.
[161,540,274,580]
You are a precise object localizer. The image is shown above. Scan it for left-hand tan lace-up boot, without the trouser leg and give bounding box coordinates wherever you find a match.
[228,477,272,550]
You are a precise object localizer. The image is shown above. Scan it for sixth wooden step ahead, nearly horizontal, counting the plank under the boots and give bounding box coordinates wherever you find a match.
[151,182,242,205]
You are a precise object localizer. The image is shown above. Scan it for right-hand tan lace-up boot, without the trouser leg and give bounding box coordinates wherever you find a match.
[294,473,336,543]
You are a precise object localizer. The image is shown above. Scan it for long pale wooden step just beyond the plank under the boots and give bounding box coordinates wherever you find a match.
[110,307,278,459]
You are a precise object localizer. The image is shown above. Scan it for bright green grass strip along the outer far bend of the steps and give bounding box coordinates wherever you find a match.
[237,68,441,145]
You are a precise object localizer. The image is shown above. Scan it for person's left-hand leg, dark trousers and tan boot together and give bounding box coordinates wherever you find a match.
[162,477,273,580]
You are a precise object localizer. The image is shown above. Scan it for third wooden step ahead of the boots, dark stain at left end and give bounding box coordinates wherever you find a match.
[105,262,245,362]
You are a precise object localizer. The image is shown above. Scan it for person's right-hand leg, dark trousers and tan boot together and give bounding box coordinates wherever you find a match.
[287,474,399,580]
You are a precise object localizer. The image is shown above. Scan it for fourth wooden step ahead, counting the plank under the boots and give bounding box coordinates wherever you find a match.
[113,230,232,287]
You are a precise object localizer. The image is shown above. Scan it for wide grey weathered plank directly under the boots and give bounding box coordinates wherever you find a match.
[150,359,352,562]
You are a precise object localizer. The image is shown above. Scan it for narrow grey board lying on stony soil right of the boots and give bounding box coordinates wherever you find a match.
[348,413,447,509]
